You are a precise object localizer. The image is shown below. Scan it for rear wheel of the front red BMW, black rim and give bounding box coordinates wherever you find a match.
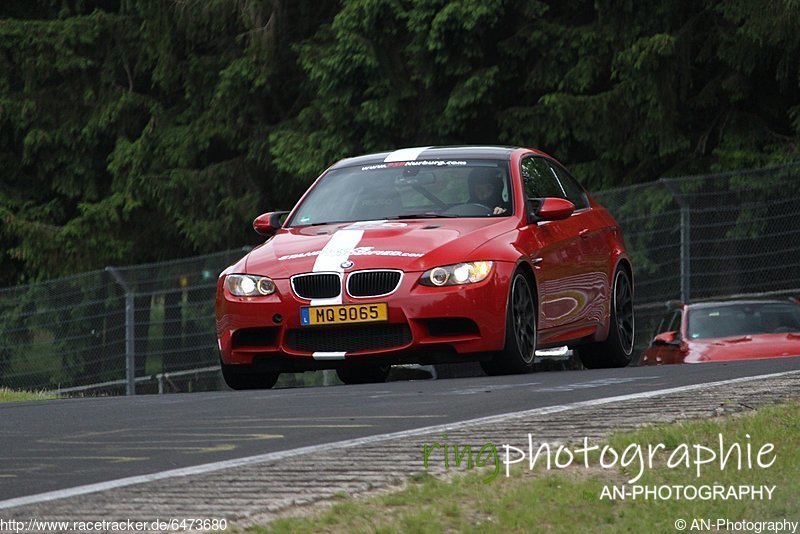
[577,266,635,369]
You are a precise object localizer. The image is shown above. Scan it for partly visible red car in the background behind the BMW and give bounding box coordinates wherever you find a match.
[640,300,800,365]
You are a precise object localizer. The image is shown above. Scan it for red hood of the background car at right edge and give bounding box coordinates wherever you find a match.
[685,333,800,362]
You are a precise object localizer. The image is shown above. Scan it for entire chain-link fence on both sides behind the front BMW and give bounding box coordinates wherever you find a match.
[0,164,800,393]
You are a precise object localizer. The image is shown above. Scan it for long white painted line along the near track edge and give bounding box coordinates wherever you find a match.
[0,371,800,510]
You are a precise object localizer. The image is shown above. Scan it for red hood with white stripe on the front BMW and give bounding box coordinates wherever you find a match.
[246,217,515,278]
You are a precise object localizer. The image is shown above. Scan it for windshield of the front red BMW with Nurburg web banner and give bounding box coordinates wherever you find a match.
[287,160,513,227]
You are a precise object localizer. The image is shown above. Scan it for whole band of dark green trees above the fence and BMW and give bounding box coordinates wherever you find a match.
[0,0,800,286]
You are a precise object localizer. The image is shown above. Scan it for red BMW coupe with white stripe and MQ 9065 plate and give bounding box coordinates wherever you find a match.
[216,147,634,389]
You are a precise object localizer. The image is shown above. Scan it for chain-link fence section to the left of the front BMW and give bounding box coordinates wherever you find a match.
[0,249,250,393]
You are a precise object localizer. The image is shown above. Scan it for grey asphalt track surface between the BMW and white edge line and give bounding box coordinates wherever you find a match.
[0,357,800,501]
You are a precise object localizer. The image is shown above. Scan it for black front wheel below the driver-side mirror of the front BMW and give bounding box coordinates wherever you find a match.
[481,271,537,376]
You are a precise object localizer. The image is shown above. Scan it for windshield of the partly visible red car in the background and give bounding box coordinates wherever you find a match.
[687,302,800,339]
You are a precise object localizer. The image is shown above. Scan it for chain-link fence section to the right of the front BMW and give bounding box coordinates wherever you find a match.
[594,163,800,351]
